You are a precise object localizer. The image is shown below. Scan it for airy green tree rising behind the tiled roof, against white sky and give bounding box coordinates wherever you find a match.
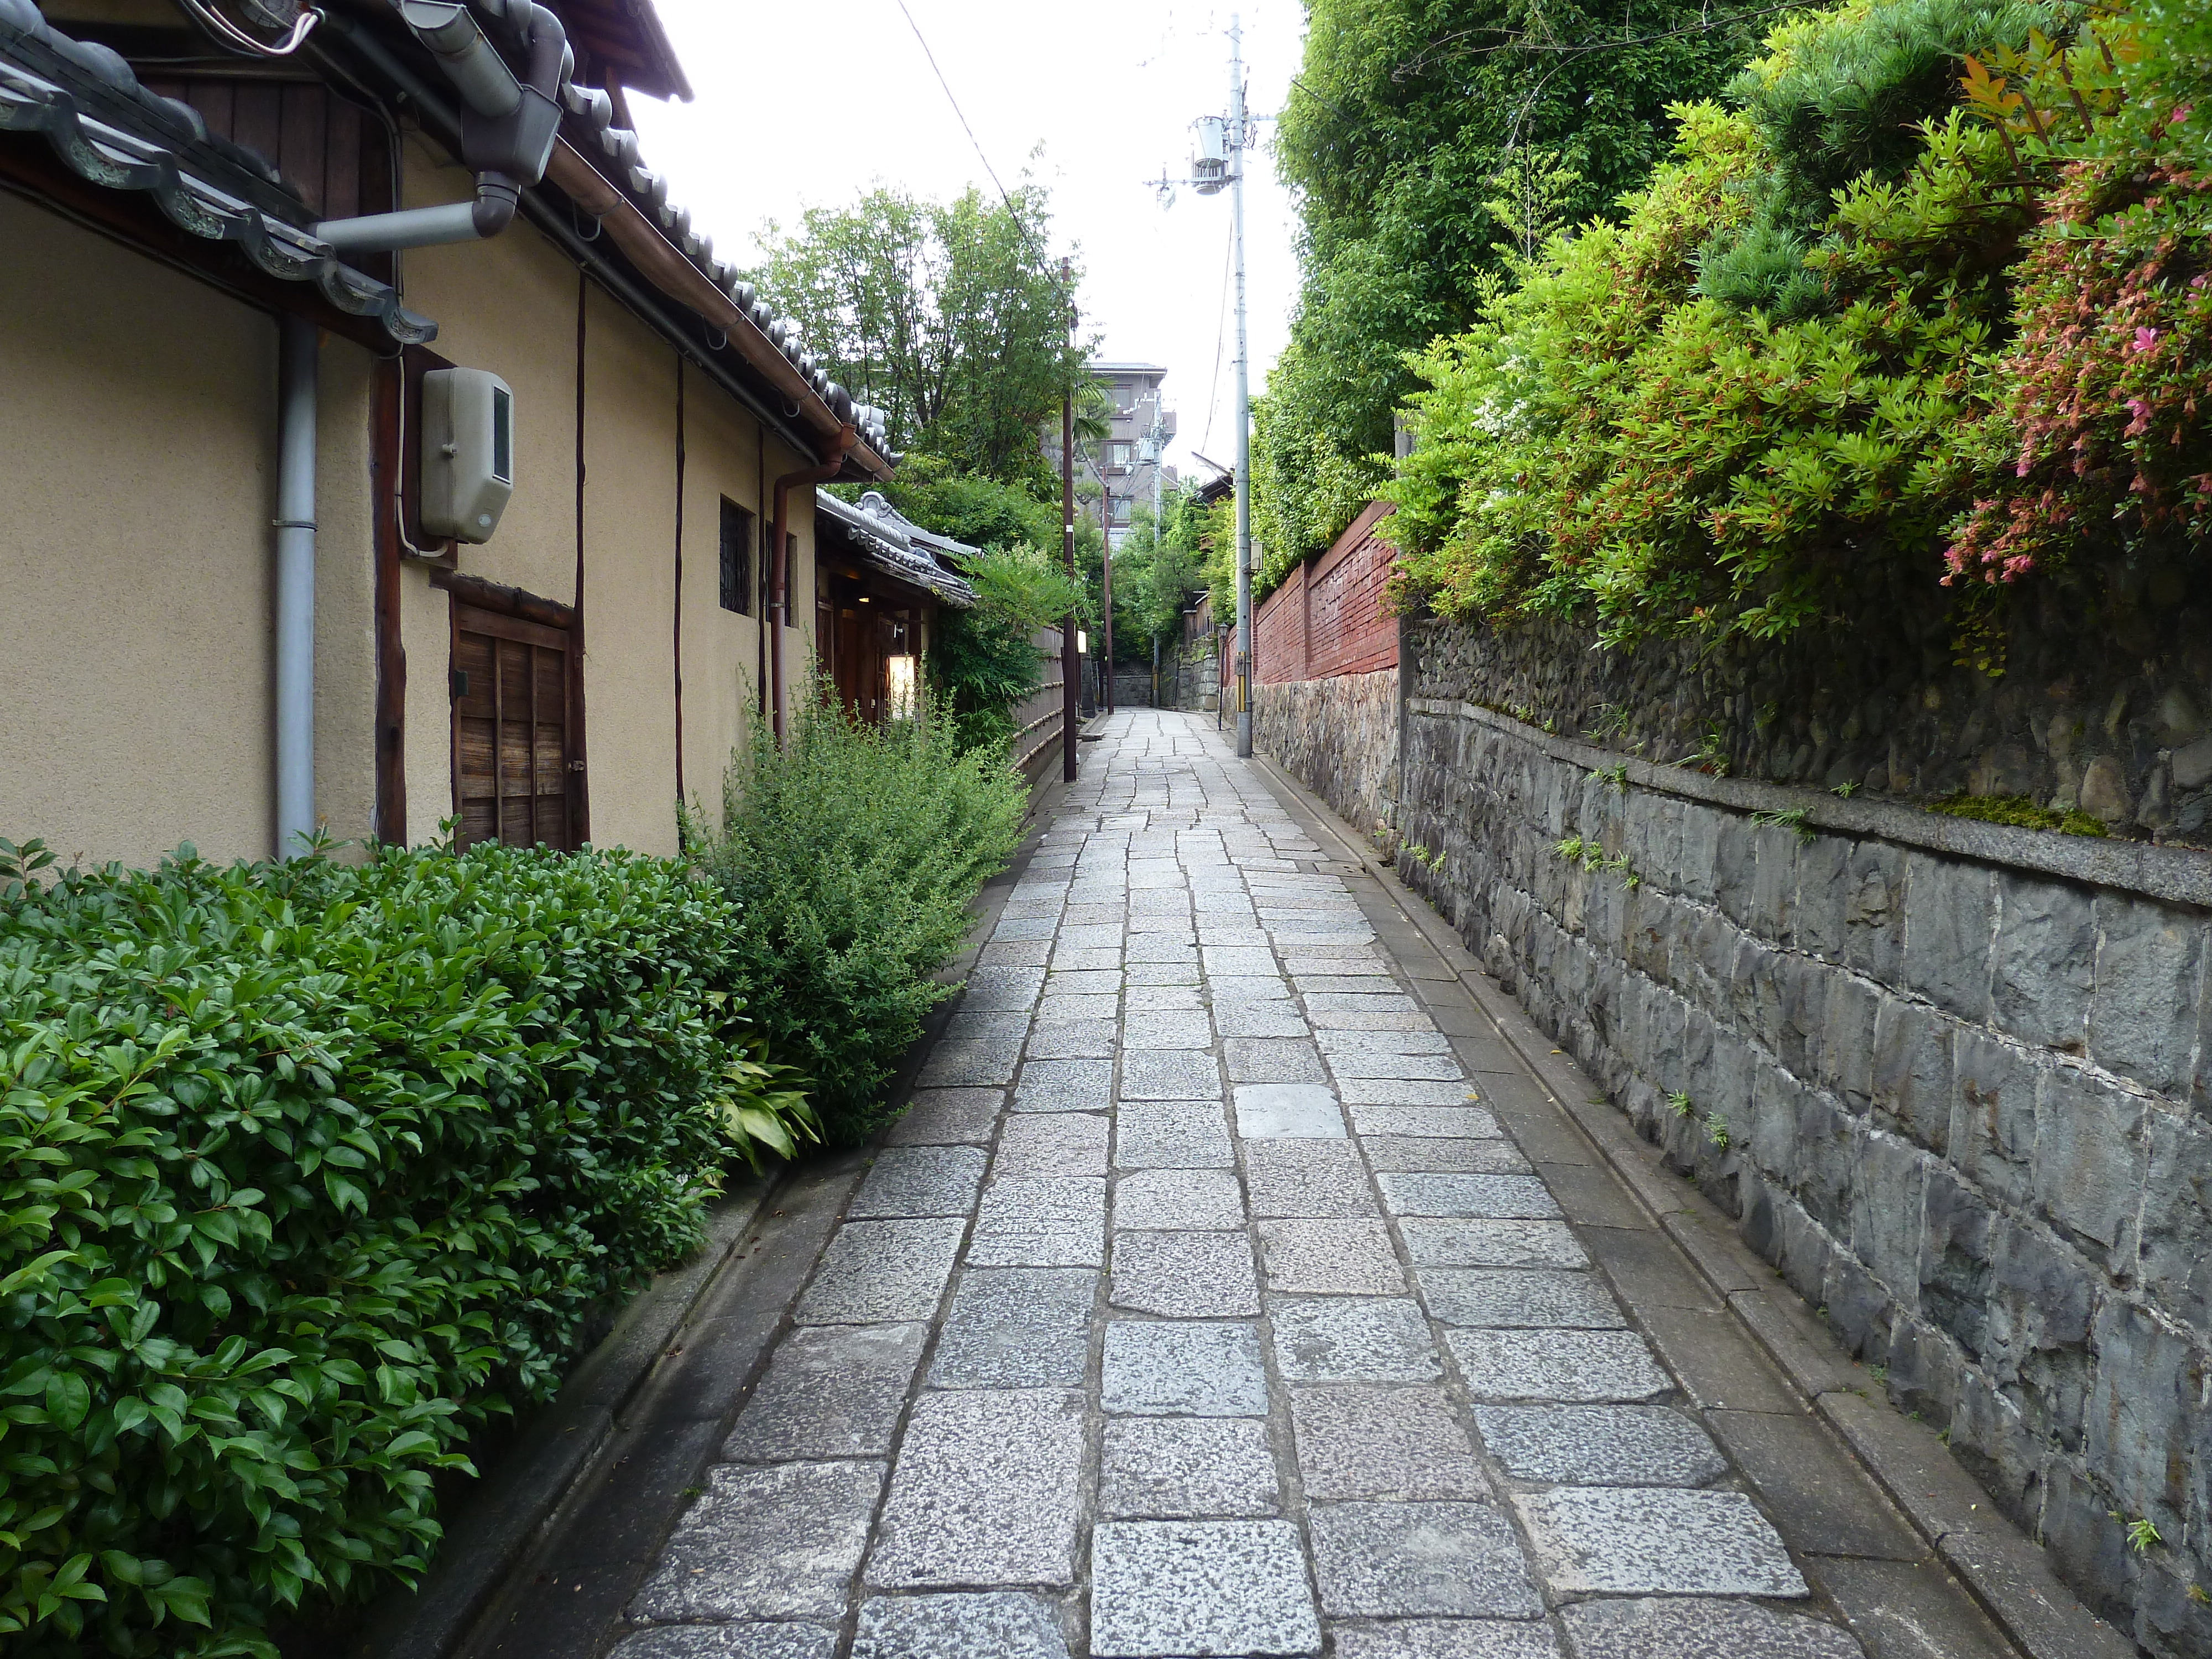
[752,184,1088,495]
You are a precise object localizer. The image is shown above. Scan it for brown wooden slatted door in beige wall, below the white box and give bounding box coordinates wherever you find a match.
[453,602,580,852]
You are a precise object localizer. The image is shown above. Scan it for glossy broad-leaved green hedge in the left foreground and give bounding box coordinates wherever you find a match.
[0,843,805,1659]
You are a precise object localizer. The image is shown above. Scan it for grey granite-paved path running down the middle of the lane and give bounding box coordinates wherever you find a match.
[615,712,1863,1659]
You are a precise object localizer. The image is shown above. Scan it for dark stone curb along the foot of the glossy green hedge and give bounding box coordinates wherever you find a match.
[345,1168,785,1659]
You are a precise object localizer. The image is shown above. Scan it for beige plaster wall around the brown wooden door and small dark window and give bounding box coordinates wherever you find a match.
[385,142,814,854]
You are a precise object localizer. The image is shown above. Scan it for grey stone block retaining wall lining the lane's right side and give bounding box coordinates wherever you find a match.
[1398,677,2212,1659]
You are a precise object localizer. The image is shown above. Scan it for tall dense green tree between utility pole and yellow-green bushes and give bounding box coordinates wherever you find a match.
[1252,0,1770,580]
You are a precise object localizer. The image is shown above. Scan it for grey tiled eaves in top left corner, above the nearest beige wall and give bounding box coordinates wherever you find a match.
[0,0,438,345]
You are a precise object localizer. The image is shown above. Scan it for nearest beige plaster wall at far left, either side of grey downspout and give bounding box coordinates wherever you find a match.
[0,195,374,865]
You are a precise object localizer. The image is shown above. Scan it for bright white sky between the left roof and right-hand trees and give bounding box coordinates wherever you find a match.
[633,0,1305,484]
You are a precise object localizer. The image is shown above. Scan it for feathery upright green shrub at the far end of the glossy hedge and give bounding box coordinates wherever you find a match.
[686,684,1024,1146]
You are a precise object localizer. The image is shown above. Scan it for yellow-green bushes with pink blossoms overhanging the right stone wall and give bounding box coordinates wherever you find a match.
[1385,0,2212,668]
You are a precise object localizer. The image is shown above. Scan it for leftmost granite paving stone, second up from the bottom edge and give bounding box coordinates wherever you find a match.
[630,1462,883,1619]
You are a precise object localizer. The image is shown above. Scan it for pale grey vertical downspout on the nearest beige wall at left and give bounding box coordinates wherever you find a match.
[276,316,321,858]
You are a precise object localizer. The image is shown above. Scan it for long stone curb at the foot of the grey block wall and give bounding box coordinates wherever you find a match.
[1254,752,2132,1659]
